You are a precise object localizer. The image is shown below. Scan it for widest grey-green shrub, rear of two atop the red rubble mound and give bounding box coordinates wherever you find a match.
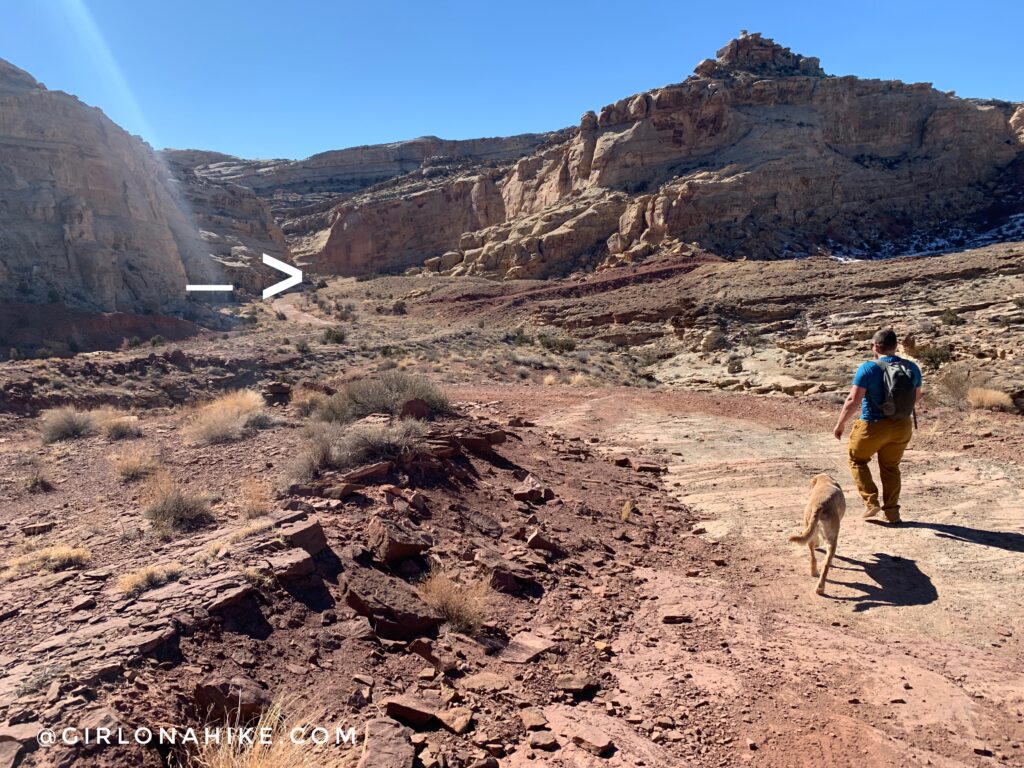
[317,371,453,423]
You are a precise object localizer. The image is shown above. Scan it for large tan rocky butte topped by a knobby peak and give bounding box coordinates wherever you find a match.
[405,35,1024,278]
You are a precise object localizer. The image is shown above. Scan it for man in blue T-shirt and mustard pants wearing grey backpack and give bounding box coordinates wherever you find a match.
[833,328,921,524]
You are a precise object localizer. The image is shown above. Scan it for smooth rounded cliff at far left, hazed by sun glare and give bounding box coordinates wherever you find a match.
[0,60,219,312]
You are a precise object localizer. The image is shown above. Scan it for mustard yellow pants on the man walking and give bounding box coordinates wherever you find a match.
[850,418,913,521]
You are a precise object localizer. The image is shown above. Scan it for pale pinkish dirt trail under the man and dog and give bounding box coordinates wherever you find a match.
[543,394,1024,766]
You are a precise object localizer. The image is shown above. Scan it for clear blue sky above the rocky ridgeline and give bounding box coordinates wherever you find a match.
[0,0,1024,158]
